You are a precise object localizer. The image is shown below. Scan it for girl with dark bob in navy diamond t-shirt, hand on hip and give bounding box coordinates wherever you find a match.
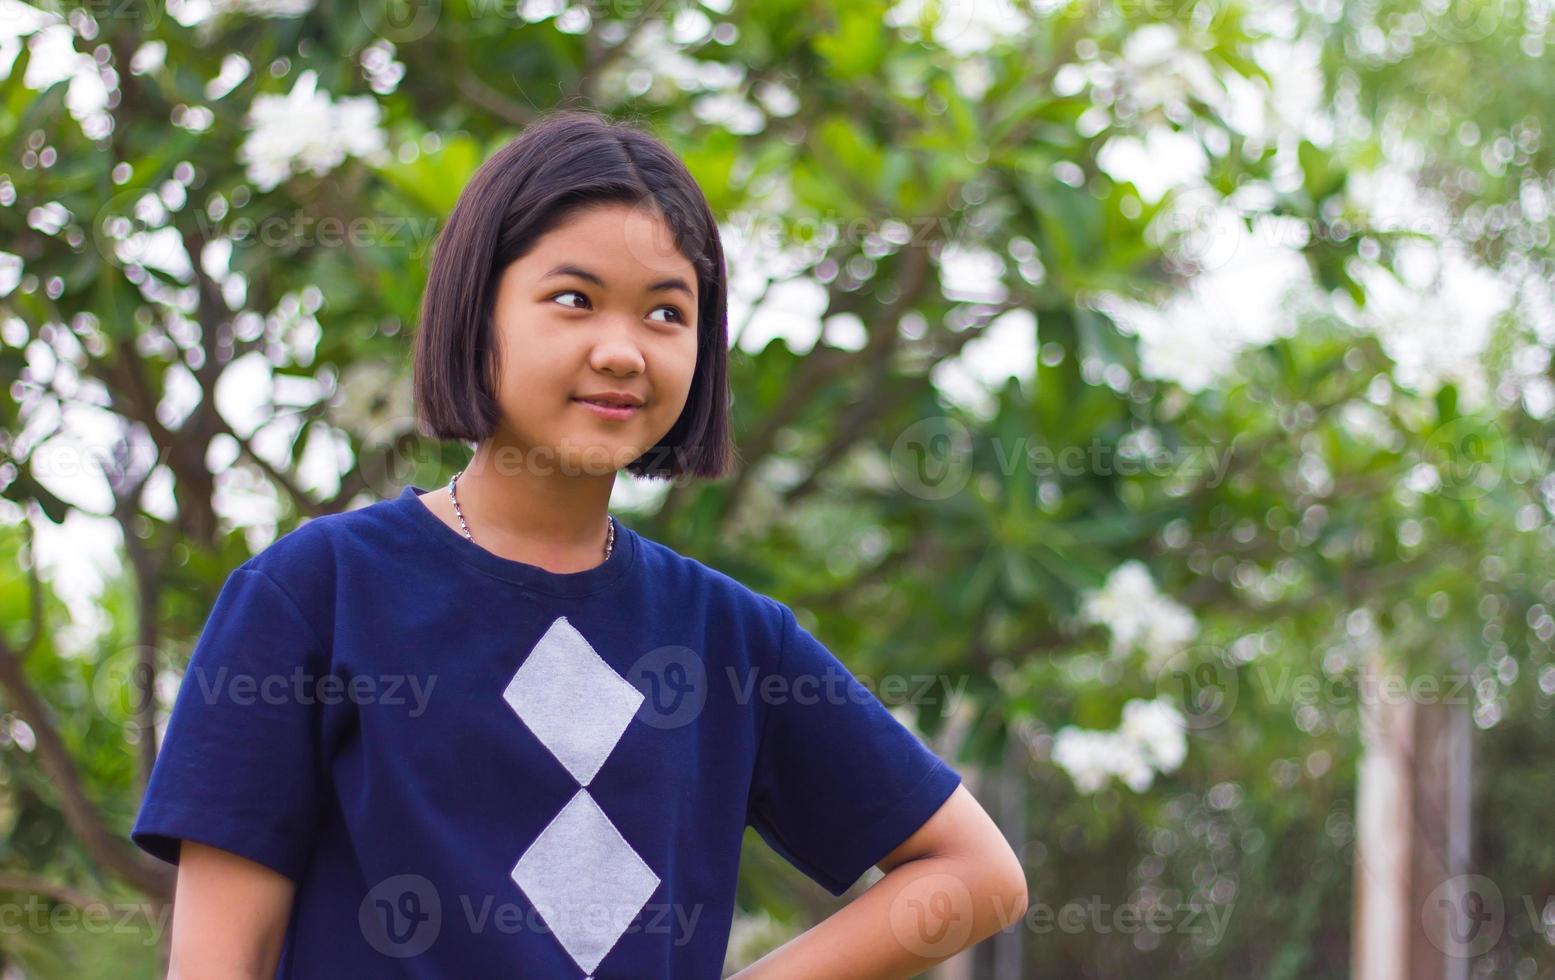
[131,112,1026,980]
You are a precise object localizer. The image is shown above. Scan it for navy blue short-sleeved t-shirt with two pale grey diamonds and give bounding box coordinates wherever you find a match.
[131,487,961,980]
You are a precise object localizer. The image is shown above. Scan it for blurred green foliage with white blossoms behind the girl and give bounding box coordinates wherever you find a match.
[0,0,1555,978]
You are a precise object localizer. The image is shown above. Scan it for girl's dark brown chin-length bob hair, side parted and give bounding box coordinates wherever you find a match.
[414,109,734,479]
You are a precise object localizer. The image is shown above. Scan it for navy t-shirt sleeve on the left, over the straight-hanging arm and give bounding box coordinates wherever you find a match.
[131,566,323,880]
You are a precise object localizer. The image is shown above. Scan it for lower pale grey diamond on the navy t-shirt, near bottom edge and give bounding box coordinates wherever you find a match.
[512,789,659,972]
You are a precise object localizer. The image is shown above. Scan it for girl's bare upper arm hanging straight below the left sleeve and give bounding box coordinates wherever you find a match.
[168,840,297,980]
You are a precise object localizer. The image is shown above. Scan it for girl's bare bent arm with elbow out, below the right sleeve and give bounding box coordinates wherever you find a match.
[731,786,1026,980]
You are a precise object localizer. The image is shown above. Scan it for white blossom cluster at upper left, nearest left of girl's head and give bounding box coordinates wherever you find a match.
[238,68,387,190]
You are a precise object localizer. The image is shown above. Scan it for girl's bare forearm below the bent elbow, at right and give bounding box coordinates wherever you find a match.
[729,857,1026,980]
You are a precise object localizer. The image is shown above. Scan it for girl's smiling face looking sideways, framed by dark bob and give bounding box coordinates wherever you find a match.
[493,204,700,474]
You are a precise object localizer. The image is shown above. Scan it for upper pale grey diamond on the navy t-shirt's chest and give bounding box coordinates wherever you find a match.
[502,616,642,786]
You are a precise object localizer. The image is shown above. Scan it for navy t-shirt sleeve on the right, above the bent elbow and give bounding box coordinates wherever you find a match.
[746,604,961,896]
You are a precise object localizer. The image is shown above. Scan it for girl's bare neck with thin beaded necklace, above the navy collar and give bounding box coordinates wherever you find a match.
[456,440,616,572]
